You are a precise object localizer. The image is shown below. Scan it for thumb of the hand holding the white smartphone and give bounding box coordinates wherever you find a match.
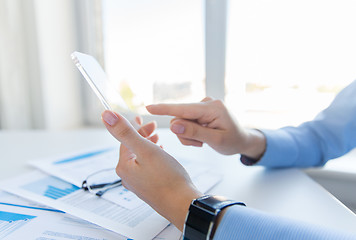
[101,110,147,154]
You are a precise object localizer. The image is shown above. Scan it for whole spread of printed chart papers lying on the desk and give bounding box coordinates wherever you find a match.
[0,148,221,239]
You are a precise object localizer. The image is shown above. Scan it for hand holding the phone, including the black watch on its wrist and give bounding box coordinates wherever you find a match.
[102,111,244,240]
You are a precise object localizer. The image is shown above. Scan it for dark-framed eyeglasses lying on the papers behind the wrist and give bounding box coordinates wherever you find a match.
[82,168,122,197]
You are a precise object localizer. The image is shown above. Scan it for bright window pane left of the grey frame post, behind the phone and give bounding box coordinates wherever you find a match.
[103,0,205,117]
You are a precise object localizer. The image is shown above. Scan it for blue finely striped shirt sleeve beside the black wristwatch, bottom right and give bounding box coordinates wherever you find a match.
[214,206,356,240]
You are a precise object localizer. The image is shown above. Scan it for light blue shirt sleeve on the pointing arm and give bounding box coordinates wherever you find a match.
[257,81,356,167]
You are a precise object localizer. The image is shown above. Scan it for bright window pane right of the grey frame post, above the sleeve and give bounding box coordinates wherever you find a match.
[226,0,356,128]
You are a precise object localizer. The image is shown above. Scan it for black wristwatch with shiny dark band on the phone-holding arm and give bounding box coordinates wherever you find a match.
[183,195,246,240]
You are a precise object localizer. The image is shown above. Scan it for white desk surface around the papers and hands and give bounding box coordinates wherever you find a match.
[0,129,356,233]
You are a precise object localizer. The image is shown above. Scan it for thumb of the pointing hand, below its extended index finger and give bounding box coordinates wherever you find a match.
[170,119,220,144]
